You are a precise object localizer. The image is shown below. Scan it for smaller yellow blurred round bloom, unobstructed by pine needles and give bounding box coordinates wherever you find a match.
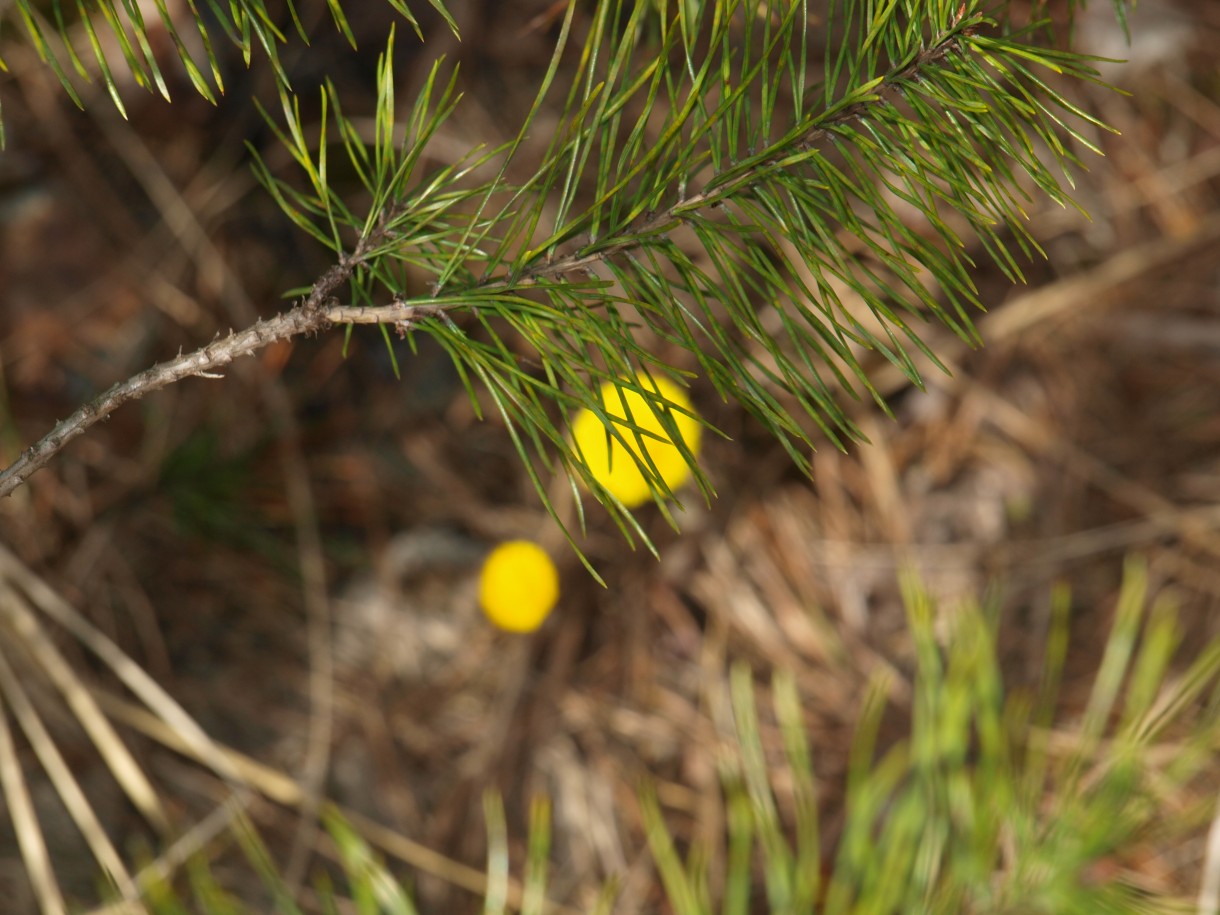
[478,540,559,632]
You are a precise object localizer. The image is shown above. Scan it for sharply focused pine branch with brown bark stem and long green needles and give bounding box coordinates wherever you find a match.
[0,0,1117,533]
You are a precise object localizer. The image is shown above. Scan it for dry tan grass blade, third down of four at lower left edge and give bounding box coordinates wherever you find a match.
[0,654,144,911]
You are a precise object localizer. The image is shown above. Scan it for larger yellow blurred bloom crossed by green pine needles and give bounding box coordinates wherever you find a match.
[572,378,703,509]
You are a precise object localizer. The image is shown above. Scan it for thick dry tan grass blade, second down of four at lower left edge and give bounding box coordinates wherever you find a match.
[0,583,170,832]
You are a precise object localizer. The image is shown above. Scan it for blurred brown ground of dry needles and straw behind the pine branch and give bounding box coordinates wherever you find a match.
[0,0,1220,911]
